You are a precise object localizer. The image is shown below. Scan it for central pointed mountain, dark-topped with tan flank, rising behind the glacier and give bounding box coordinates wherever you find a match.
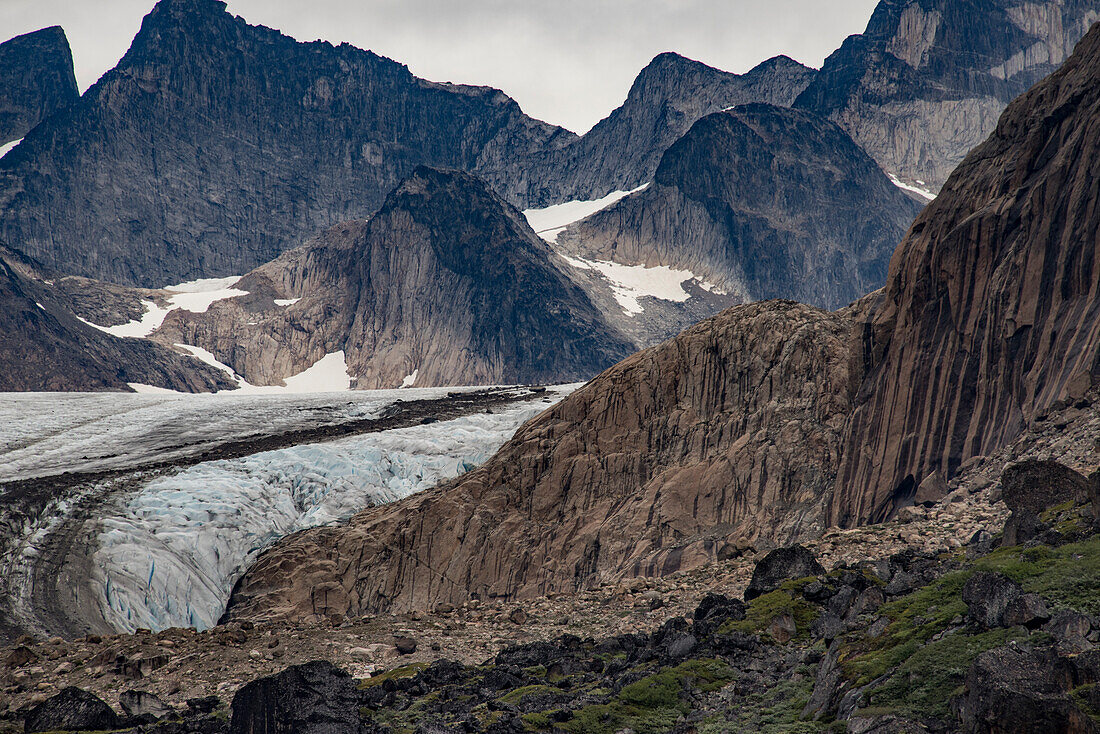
[156,167,634,388]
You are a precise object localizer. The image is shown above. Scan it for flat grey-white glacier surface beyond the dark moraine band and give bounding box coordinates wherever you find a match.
[0,387,492,482]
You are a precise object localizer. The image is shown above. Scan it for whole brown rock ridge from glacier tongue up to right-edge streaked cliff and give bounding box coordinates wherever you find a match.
[221,21,1100,617]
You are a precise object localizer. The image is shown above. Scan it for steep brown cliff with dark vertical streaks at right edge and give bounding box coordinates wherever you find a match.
[831,21,1100,525]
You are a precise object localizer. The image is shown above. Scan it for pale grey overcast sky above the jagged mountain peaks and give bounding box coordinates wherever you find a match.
[0,0,877,132]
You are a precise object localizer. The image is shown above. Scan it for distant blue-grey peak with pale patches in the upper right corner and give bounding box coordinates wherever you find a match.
[795,0,1100,189]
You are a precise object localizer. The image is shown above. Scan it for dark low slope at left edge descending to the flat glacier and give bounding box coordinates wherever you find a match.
[0,249,235,392]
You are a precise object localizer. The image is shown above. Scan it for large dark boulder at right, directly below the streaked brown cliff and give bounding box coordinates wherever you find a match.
[1001,459,1089,546]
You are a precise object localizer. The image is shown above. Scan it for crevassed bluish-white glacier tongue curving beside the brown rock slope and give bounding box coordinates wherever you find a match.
[92,385,576,631]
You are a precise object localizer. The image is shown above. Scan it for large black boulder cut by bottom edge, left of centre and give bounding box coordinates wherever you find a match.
[229,661,365,734]
